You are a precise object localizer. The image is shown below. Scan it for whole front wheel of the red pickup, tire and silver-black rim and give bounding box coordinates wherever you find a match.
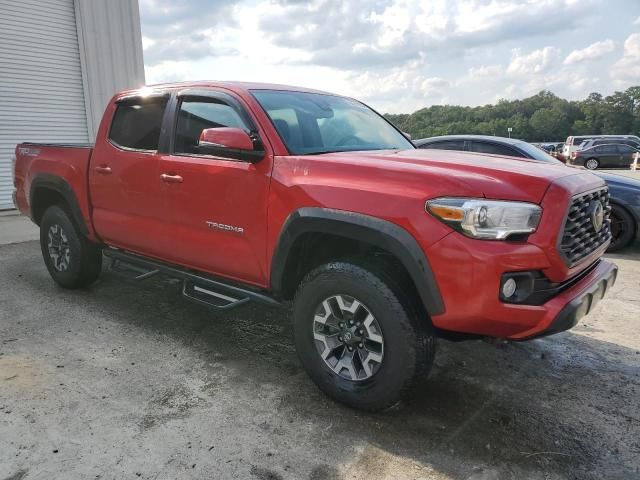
[294,262,435,411]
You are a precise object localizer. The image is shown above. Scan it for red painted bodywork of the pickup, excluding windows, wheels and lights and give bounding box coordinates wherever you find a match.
[16,82,616,338]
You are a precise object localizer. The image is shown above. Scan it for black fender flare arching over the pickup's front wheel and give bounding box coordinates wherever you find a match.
[271,207,445,316]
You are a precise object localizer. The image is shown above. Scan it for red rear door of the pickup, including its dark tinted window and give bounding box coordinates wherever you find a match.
[89,95,169,257]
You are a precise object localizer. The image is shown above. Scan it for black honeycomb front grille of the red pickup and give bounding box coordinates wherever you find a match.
[560,187,611,267]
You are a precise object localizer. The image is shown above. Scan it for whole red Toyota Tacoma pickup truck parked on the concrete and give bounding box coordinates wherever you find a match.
[15,82,617,410]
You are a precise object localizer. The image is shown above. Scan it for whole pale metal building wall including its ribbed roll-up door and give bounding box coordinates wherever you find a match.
[0,0,144,210]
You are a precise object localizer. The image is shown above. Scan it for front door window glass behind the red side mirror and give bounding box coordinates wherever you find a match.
[174,98,250,154]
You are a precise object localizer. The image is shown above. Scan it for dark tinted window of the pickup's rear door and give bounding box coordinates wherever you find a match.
[109,97,168,150]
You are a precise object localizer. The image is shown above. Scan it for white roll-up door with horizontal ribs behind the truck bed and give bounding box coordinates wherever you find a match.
[0,0,89,209]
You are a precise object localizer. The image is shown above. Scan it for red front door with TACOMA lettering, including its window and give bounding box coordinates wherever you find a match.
[159,90,272,286]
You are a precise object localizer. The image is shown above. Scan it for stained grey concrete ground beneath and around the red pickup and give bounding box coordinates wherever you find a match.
[0,219,640,480]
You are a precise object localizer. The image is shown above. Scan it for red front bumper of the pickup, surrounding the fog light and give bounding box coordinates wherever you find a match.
[427,228,617,340]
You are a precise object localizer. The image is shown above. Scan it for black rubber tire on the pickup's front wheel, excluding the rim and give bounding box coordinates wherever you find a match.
[293,262,436,411]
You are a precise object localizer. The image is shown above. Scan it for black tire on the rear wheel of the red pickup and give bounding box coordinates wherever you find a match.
[40,205,102,288]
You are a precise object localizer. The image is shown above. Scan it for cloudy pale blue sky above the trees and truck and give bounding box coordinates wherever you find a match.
[139,0,640,113]
